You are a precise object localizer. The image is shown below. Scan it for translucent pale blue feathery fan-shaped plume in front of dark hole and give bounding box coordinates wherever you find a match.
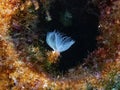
[46,31,75,53]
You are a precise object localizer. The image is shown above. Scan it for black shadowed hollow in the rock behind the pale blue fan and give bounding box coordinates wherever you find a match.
[38,0,100,71]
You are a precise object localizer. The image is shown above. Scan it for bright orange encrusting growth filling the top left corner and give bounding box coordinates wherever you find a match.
[0,0,20,36]
